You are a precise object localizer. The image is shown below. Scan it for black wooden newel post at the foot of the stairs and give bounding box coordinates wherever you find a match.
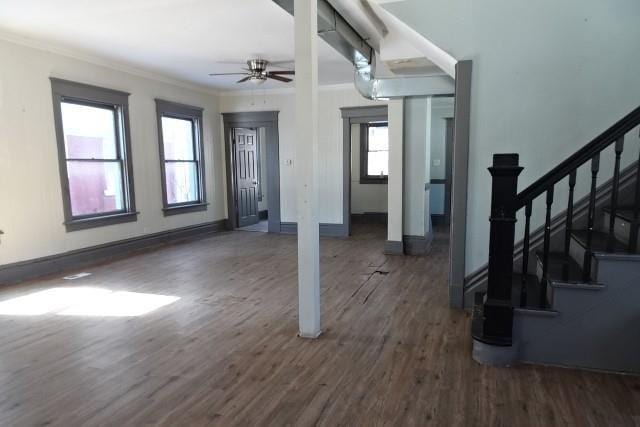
[481,154,522,345]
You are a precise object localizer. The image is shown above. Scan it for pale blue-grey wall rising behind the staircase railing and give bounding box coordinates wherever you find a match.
[385,0,640,273]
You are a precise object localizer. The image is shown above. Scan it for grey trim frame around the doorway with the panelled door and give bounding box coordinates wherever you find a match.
[222,111,280,233]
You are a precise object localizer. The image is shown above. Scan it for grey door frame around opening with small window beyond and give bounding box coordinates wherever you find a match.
[340,105,389,236]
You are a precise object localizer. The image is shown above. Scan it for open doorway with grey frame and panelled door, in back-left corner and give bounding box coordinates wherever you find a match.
[223,112,280,233]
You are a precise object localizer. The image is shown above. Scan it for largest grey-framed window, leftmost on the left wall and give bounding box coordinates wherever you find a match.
[51,78,137,231]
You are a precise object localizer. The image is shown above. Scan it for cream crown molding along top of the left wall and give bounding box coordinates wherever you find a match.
[0,30,220,96]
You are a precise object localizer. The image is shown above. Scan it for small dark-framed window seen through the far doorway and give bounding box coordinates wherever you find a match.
[360,122,389,184]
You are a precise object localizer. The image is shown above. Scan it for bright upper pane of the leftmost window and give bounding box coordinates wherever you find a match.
[61,102,117,159]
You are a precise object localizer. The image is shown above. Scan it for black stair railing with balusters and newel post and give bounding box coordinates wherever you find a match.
[474,107,640,345]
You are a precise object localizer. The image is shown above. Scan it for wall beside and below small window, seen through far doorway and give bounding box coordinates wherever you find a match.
[351,124,388,214]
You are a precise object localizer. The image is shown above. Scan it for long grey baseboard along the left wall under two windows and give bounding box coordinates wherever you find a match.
[0,219,228,285]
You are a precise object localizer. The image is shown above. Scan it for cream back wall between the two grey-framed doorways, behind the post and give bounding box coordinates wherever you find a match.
[220,85,384,224]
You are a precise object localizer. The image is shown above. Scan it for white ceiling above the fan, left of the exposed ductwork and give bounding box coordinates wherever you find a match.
[0,0,353,90]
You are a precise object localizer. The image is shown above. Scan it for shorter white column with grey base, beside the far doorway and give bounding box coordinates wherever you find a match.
[385,99,404,254]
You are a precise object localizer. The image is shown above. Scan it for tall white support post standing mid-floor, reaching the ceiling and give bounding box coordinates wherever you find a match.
[294,0,321,338]
